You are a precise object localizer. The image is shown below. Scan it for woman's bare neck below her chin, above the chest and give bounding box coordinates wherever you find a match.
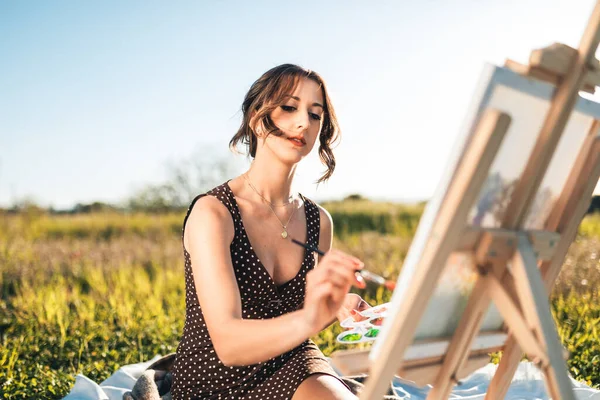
[245,159,296,205]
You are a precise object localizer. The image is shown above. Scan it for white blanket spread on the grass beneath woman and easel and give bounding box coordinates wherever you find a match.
[63,355,600,400]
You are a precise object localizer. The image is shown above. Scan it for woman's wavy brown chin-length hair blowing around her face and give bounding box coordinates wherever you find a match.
[229,64,340,183]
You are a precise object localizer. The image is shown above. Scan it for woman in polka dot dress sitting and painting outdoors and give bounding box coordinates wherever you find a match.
[171,64,368,400]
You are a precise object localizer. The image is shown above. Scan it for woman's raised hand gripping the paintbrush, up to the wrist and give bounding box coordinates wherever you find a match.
[303,249,364,336]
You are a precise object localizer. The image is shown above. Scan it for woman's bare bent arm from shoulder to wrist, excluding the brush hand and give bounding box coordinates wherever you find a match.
[186,196,311,365]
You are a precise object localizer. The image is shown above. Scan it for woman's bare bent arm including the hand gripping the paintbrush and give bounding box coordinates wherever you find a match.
[185,196,360,366]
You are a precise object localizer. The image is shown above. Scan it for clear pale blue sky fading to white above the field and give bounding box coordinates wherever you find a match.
[0,0,600,208]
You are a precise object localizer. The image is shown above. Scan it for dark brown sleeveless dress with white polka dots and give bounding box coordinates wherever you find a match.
[171,181,345,400]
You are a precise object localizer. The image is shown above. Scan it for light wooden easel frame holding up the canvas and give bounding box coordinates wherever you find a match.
[352,1,600,400]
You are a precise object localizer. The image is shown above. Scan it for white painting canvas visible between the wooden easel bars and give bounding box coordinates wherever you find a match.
[369,64,600,361]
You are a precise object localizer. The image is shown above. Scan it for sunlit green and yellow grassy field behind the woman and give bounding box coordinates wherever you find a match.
[0,206,600,399]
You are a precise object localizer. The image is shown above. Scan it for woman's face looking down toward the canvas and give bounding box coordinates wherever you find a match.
[264,78,323,163]
